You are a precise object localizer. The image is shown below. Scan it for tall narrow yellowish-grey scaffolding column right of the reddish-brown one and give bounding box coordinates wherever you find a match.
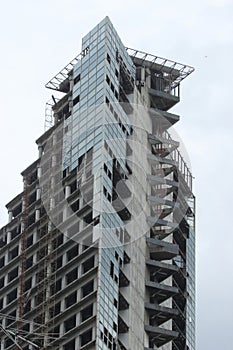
[36,136,59,350]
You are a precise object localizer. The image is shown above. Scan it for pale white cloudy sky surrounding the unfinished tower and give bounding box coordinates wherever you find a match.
[0,0,233,350]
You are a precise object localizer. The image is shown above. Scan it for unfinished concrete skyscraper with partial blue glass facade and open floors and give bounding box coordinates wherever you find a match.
[0,17,195,350]
